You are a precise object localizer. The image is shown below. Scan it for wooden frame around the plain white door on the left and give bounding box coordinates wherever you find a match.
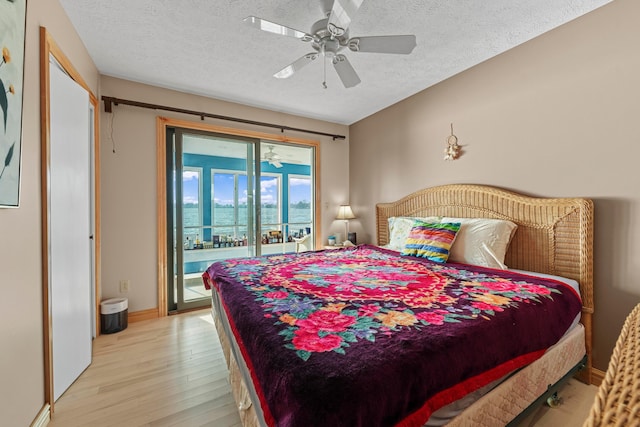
[40,27,100,413]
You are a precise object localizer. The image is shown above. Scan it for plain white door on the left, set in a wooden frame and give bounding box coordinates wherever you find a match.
[49,63,93,401]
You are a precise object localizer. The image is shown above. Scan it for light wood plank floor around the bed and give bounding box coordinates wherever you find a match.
[49,309,597,427]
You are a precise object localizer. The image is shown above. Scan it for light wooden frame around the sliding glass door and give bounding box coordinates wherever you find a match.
[156,116,322,317]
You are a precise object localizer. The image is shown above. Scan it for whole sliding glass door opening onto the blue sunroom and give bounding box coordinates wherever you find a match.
[167,128,315,311]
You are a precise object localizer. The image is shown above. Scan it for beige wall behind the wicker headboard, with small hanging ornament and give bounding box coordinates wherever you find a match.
[350,0,640,370]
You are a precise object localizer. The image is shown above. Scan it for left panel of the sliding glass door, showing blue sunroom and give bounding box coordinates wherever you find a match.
[174,129,259,311]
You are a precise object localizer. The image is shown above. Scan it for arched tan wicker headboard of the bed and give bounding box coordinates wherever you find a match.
[376,184,594,384]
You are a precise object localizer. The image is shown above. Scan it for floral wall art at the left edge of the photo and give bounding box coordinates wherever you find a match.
[0,0,27,208]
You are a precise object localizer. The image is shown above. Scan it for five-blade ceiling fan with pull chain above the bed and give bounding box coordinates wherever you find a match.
[244,0,416,89]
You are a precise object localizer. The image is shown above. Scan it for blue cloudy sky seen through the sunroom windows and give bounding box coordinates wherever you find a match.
[183,171,311,204]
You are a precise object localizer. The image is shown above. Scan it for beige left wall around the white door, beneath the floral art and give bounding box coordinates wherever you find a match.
[0,0,98,426]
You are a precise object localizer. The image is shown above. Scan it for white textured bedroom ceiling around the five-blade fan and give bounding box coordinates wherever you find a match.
[60,0,611,125]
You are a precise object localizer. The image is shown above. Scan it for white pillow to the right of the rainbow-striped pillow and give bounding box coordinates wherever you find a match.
[442,217,518,270]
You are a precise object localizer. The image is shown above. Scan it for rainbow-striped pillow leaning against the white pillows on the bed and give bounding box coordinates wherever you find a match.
[402,221,460,263]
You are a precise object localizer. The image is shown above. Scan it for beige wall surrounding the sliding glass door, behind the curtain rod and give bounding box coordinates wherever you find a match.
[101,77,349,312]
